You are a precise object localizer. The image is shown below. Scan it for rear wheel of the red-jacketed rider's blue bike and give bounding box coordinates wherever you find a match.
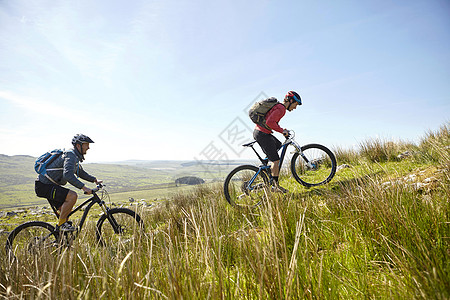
[223,165,269,207]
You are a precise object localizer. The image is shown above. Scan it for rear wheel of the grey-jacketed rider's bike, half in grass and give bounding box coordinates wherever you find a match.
[6,221,58,259]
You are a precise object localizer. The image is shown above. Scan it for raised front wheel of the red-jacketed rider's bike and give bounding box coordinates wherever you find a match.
[291,144,336,187]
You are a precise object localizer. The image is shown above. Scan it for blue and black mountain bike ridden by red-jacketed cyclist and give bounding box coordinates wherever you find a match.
[224,130,336,206]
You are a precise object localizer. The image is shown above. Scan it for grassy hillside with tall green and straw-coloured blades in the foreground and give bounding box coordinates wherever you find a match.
[0,126,450,299]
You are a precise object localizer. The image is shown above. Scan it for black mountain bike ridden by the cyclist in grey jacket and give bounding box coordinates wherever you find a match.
[6,184,144,259]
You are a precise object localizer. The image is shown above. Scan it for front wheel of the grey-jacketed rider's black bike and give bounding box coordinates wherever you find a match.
[96,207,144,246]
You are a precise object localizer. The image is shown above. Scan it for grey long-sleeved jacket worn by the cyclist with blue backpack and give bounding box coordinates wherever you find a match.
[37,149,95,189]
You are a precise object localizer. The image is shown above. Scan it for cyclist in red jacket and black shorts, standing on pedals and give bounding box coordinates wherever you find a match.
[253,91,302,193]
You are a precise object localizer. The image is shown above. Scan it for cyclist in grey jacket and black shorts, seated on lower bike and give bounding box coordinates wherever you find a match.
[35,134,101,231]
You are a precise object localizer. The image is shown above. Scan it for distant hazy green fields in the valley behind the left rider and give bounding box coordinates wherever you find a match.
[0,155,250,209]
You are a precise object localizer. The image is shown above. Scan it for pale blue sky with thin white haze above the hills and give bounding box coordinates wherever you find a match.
[0,0,450,162]
